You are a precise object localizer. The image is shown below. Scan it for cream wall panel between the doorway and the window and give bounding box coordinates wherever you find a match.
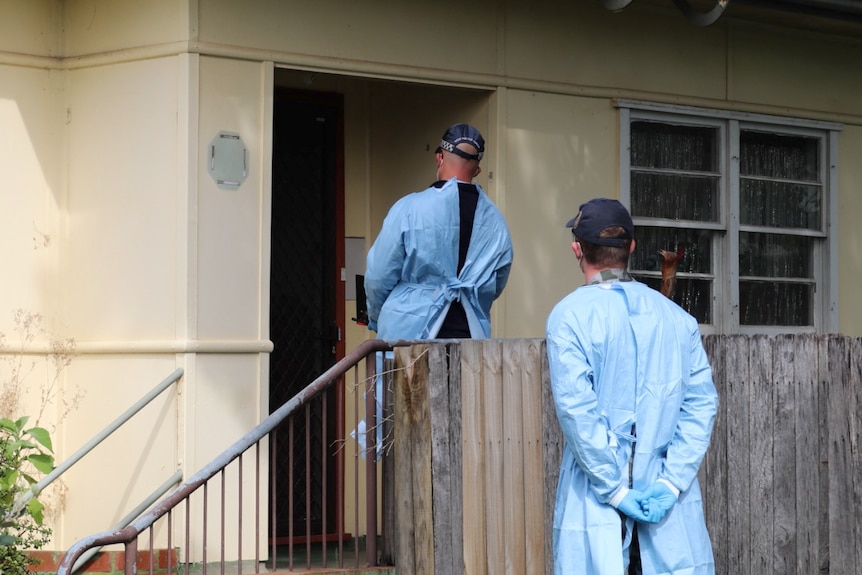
[506,90,619,337]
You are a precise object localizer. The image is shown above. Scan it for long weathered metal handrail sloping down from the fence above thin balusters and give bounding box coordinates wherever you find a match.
[57,339,402,575]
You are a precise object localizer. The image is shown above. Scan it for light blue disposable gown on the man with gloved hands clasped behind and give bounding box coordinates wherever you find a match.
[547,281,718,575]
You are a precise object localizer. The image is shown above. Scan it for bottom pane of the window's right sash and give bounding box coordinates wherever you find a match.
[739,281,814,326]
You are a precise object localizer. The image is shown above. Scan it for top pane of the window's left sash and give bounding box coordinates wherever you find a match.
[631,121,718,172]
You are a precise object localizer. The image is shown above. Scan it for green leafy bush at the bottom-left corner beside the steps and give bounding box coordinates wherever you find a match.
[0,417,54,575]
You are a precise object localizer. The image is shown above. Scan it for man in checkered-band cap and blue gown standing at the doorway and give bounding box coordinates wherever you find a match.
[365,120,513,340]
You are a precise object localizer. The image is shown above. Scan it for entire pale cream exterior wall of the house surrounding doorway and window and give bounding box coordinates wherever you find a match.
[0,0,862,564]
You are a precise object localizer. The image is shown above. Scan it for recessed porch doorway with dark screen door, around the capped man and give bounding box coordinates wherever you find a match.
[269,69,493,544]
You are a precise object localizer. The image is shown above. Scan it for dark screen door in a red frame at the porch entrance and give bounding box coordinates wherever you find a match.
[269,91,344,542]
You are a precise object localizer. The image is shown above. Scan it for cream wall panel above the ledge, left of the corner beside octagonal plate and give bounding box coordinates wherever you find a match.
[60,58,185,341]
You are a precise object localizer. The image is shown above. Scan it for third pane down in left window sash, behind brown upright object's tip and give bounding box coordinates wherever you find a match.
[629,226,714,274]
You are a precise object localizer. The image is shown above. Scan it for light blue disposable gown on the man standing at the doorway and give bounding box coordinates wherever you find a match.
[365,179,512,340]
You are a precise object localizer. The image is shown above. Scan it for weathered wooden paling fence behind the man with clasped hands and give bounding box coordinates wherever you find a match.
[384,335,862,575]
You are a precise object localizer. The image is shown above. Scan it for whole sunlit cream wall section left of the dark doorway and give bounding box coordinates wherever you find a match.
[0,2,268,549]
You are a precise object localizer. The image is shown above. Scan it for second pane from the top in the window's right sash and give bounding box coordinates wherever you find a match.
[740,178,822,230]
